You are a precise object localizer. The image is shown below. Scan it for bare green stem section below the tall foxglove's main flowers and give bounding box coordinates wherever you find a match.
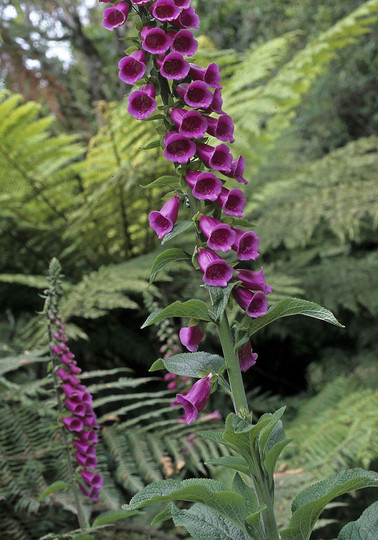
[218,312,248,418]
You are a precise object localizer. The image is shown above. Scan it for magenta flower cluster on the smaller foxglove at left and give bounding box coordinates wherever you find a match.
[51,317,103,501]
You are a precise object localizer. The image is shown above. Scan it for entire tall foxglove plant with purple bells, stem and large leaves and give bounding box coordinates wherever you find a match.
[98,0,378,540]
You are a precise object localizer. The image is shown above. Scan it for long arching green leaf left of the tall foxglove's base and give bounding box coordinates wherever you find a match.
[123,478,246,532]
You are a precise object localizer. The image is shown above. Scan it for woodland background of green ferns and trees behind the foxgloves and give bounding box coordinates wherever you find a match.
[0,0,378,540]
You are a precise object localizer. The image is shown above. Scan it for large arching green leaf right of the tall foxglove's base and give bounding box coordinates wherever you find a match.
[281,469,378,540]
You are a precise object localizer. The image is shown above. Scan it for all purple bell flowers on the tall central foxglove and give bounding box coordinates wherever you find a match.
[100,0,272,423]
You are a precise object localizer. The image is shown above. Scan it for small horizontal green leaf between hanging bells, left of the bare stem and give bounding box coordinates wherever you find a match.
[163,352,226,378]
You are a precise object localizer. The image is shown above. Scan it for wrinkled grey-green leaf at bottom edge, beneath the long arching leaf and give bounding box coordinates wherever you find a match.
[172,503,253,540]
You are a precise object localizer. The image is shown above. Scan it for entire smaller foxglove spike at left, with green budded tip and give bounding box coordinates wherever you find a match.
[44,259,103,529]
